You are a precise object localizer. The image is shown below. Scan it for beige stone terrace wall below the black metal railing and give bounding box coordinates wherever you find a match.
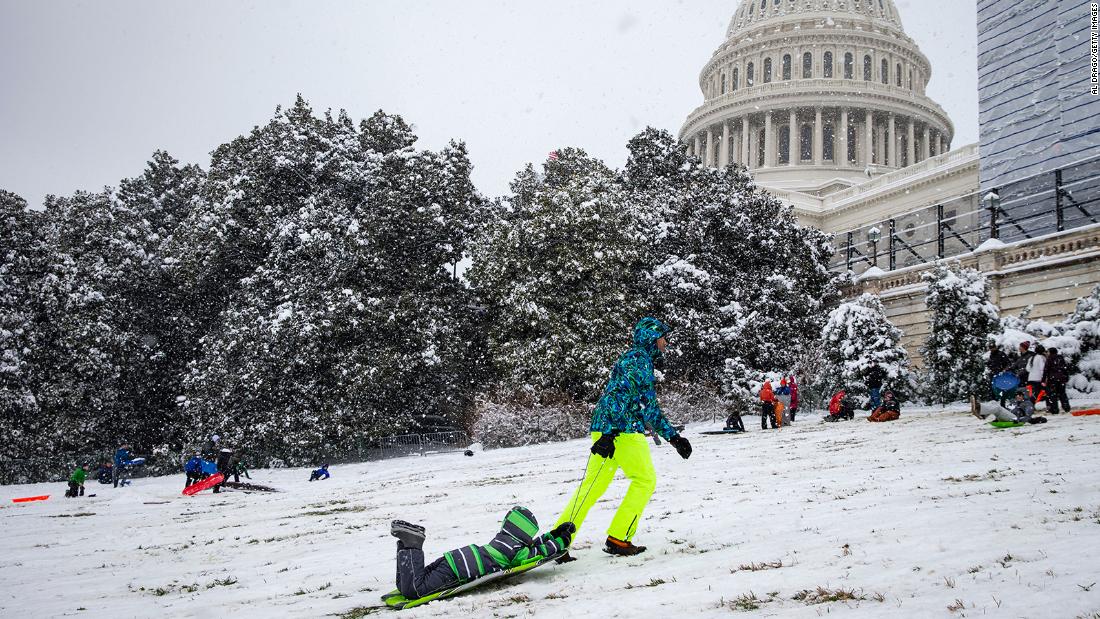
[846,225,1100,366]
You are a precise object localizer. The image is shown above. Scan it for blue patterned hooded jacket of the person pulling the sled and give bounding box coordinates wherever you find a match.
[591,318,678,440]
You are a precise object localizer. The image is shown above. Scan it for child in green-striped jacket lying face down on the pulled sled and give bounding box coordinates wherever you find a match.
[384,507,575,599]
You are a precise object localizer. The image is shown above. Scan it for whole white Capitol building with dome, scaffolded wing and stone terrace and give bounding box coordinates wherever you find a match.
[680,0,1100,353]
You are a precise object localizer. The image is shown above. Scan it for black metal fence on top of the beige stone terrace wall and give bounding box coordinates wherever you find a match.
[831,157,1100,275]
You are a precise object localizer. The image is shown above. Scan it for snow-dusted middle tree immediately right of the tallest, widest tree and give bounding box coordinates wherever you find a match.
[468,148,641,398]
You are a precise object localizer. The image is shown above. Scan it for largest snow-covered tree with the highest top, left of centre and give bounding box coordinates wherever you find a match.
[178,98,481,460]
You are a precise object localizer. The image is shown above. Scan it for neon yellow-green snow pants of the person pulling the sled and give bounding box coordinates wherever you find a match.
[558,432,657,542]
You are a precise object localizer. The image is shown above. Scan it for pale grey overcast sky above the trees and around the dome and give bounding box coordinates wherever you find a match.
[0,0,978,206]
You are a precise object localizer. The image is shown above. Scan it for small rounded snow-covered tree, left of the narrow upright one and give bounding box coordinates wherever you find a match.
[818,294,914,398]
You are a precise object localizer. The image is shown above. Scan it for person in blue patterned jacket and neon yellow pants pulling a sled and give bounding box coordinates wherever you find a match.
[558,318,691,562]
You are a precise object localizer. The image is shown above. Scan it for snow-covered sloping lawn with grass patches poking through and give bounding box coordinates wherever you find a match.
[0,404,1100,618]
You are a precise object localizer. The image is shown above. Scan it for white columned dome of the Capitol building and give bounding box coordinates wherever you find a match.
[680,0,955,197]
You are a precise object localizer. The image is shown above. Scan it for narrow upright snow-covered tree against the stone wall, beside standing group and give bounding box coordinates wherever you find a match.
[921,265,1000,404]
